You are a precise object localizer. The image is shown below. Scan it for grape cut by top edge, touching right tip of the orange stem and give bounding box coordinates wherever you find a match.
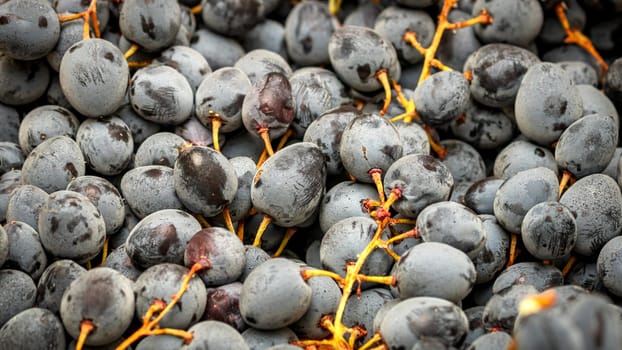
[472,0,544,46]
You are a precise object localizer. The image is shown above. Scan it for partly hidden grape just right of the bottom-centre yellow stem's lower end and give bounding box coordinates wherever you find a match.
[343,288,397,345]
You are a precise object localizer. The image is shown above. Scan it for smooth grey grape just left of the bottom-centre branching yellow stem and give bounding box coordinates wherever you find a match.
[240,258,313,330]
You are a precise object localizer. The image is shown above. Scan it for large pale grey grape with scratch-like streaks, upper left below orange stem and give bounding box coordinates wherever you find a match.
[58,39,129,118]
